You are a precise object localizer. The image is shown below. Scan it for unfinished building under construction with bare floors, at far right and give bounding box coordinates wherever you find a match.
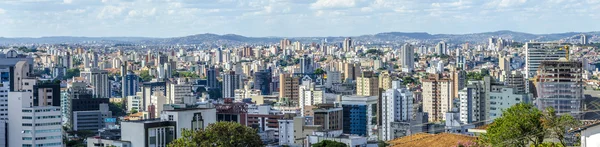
[534,61,583,118]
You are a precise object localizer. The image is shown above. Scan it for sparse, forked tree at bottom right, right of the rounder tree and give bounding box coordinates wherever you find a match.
[542,107,579,146]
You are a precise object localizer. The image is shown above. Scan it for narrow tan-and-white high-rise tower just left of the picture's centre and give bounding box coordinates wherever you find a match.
[279,74,300,105]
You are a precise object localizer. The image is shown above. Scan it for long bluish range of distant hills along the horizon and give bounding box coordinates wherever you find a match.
[0,30,600,45]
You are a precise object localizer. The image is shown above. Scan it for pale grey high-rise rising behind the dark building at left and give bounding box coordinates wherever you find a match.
[81,68,111,98]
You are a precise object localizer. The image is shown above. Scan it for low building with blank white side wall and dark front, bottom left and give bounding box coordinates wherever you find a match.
[121,119,180,147]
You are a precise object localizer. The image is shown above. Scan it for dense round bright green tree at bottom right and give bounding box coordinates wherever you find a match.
[481,103,545,147]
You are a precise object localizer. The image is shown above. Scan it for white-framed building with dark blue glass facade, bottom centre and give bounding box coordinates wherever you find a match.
[341,96,378,137]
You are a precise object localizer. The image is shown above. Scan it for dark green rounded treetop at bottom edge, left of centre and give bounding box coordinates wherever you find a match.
[168,122,263,147]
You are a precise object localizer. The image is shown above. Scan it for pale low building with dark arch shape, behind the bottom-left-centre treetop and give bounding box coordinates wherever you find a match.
[160,108,217,138]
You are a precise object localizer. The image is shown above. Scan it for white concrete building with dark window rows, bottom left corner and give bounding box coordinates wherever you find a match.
[7,92,63,147]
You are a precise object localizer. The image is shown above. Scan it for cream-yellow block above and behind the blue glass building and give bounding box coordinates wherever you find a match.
[356,72,379,96]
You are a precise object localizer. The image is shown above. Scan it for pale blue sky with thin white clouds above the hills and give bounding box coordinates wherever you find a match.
[0,0,600,37]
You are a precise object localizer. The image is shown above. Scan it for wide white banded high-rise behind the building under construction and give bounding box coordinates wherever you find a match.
[525,42,570,79]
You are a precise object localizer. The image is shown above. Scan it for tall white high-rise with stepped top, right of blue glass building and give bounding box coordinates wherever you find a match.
[380,81,413,140]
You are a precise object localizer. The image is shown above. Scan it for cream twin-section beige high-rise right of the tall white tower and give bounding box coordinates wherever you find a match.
[421,74,454,122]
